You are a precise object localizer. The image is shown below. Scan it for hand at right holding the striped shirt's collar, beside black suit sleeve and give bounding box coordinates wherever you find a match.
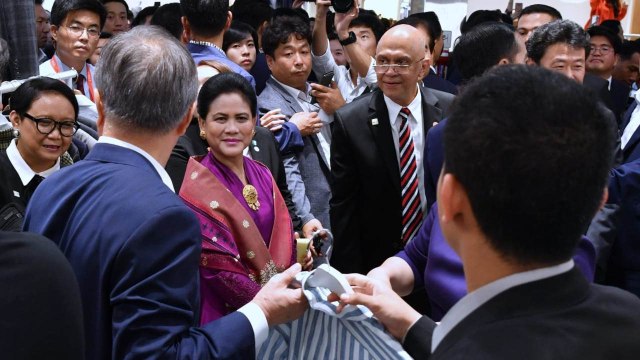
[336,274,422,341]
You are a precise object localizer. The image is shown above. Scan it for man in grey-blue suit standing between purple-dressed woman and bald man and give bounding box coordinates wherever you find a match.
[258,16,332,237]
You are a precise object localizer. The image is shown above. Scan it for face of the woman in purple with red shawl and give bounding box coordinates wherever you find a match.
[199,92,255,164]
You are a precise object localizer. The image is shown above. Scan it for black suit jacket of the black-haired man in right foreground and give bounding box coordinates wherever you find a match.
[404,267,640,360]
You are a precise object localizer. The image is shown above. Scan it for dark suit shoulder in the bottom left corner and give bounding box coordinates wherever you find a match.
[0,232,84,360]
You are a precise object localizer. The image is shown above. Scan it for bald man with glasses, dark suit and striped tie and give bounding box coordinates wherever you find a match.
[330,25,454,274]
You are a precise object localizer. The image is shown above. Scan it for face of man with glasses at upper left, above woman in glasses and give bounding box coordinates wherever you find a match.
[51,10,100,66]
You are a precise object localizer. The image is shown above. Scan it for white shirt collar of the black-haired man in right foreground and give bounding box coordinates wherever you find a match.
[431,259,574,354]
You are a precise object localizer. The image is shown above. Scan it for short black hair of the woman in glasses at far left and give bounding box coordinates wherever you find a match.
[9,76,78,120]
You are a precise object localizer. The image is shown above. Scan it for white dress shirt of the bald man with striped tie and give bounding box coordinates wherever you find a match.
[384,84,427,216]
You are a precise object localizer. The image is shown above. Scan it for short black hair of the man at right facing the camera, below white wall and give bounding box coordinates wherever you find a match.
[527,20,591,65]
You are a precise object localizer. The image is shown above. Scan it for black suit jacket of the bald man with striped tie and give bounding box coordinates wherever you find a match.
[331,88,453,274]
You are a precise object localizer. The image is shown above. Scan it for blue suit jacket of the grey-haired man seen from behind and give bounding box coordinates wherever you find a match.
[24,143,255,359]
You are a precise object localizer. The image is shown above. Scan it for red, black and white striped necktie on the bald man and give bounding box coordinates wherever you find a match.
[398,107,422,244]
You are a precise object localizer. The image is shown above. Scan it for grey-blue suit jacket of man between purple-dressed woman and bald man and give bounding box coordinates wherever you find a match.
[258,78,331,229]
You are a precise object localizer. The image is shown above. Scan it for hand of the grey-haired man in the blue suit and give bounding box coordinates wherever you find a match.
[252,263,309,327]
